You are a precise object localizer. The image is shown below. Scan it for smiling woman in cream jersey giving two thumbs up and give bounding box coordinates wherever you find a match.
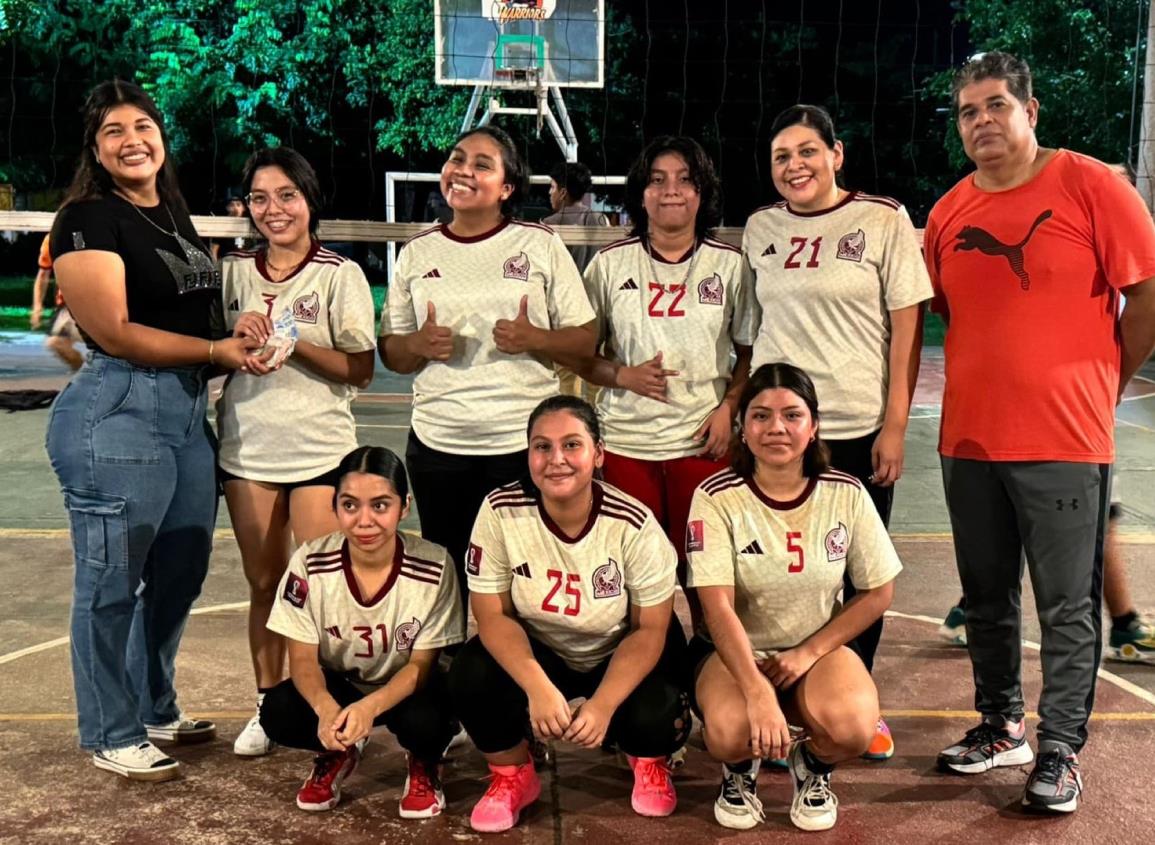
[378,126,594,600]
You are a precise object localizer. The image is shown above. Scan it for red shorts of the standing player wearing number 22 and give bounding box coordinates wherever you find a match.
[603,451,730,561]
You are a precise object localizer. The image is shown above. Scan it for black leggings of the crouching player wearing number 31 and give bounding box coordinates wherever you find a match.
[261,670,457,761]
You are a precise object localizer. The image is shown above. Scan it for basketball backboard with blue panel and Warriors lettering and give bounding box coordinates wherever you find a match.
[433,0,605,89]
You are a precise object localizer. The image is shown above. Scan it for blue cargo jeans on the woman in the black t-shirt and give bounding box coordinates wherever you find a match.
[47,354,217,748]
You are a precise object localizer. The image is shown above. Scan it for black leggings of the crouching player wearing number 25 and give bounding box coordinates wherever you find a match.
[449,620,691,757]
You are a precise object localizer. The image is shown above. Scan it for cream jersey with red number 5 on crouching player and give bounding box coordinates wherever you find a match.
[686,470,902,653]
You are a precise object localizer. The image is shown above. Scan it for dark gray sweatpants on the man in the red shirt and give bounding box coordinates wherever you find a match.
[942,457,1111,751]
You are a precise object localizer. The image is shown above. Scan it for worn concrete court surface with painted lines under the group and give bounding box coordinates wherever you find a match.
[0,336,1155,845]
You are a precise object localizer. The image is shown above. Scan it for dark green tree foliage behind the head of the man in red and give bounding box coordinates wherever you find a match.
[923,0,1148,169]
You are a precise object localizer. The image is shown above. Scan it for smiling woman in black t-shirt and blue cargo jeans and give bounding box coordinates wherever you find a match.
[47,81,253,780]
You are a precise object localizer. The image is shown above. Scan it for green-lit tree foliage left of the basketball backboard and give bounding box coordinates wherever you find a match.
[3,0,467,183]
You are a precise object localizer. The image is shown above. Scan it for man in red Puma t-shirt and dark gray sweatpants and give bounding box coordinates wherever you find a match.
[925,52,1155,813]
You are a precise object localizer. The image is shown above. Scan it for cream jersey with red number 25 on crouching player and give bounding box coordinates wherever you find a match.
[465,481,677,672]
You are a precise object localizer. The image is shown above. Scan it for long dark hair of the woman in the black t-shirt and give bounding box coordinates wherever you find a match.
[60,80,188,214]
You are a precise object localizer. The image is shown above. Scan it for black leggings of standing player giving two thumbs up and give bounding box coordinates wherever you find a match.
[405,431,527,612]
